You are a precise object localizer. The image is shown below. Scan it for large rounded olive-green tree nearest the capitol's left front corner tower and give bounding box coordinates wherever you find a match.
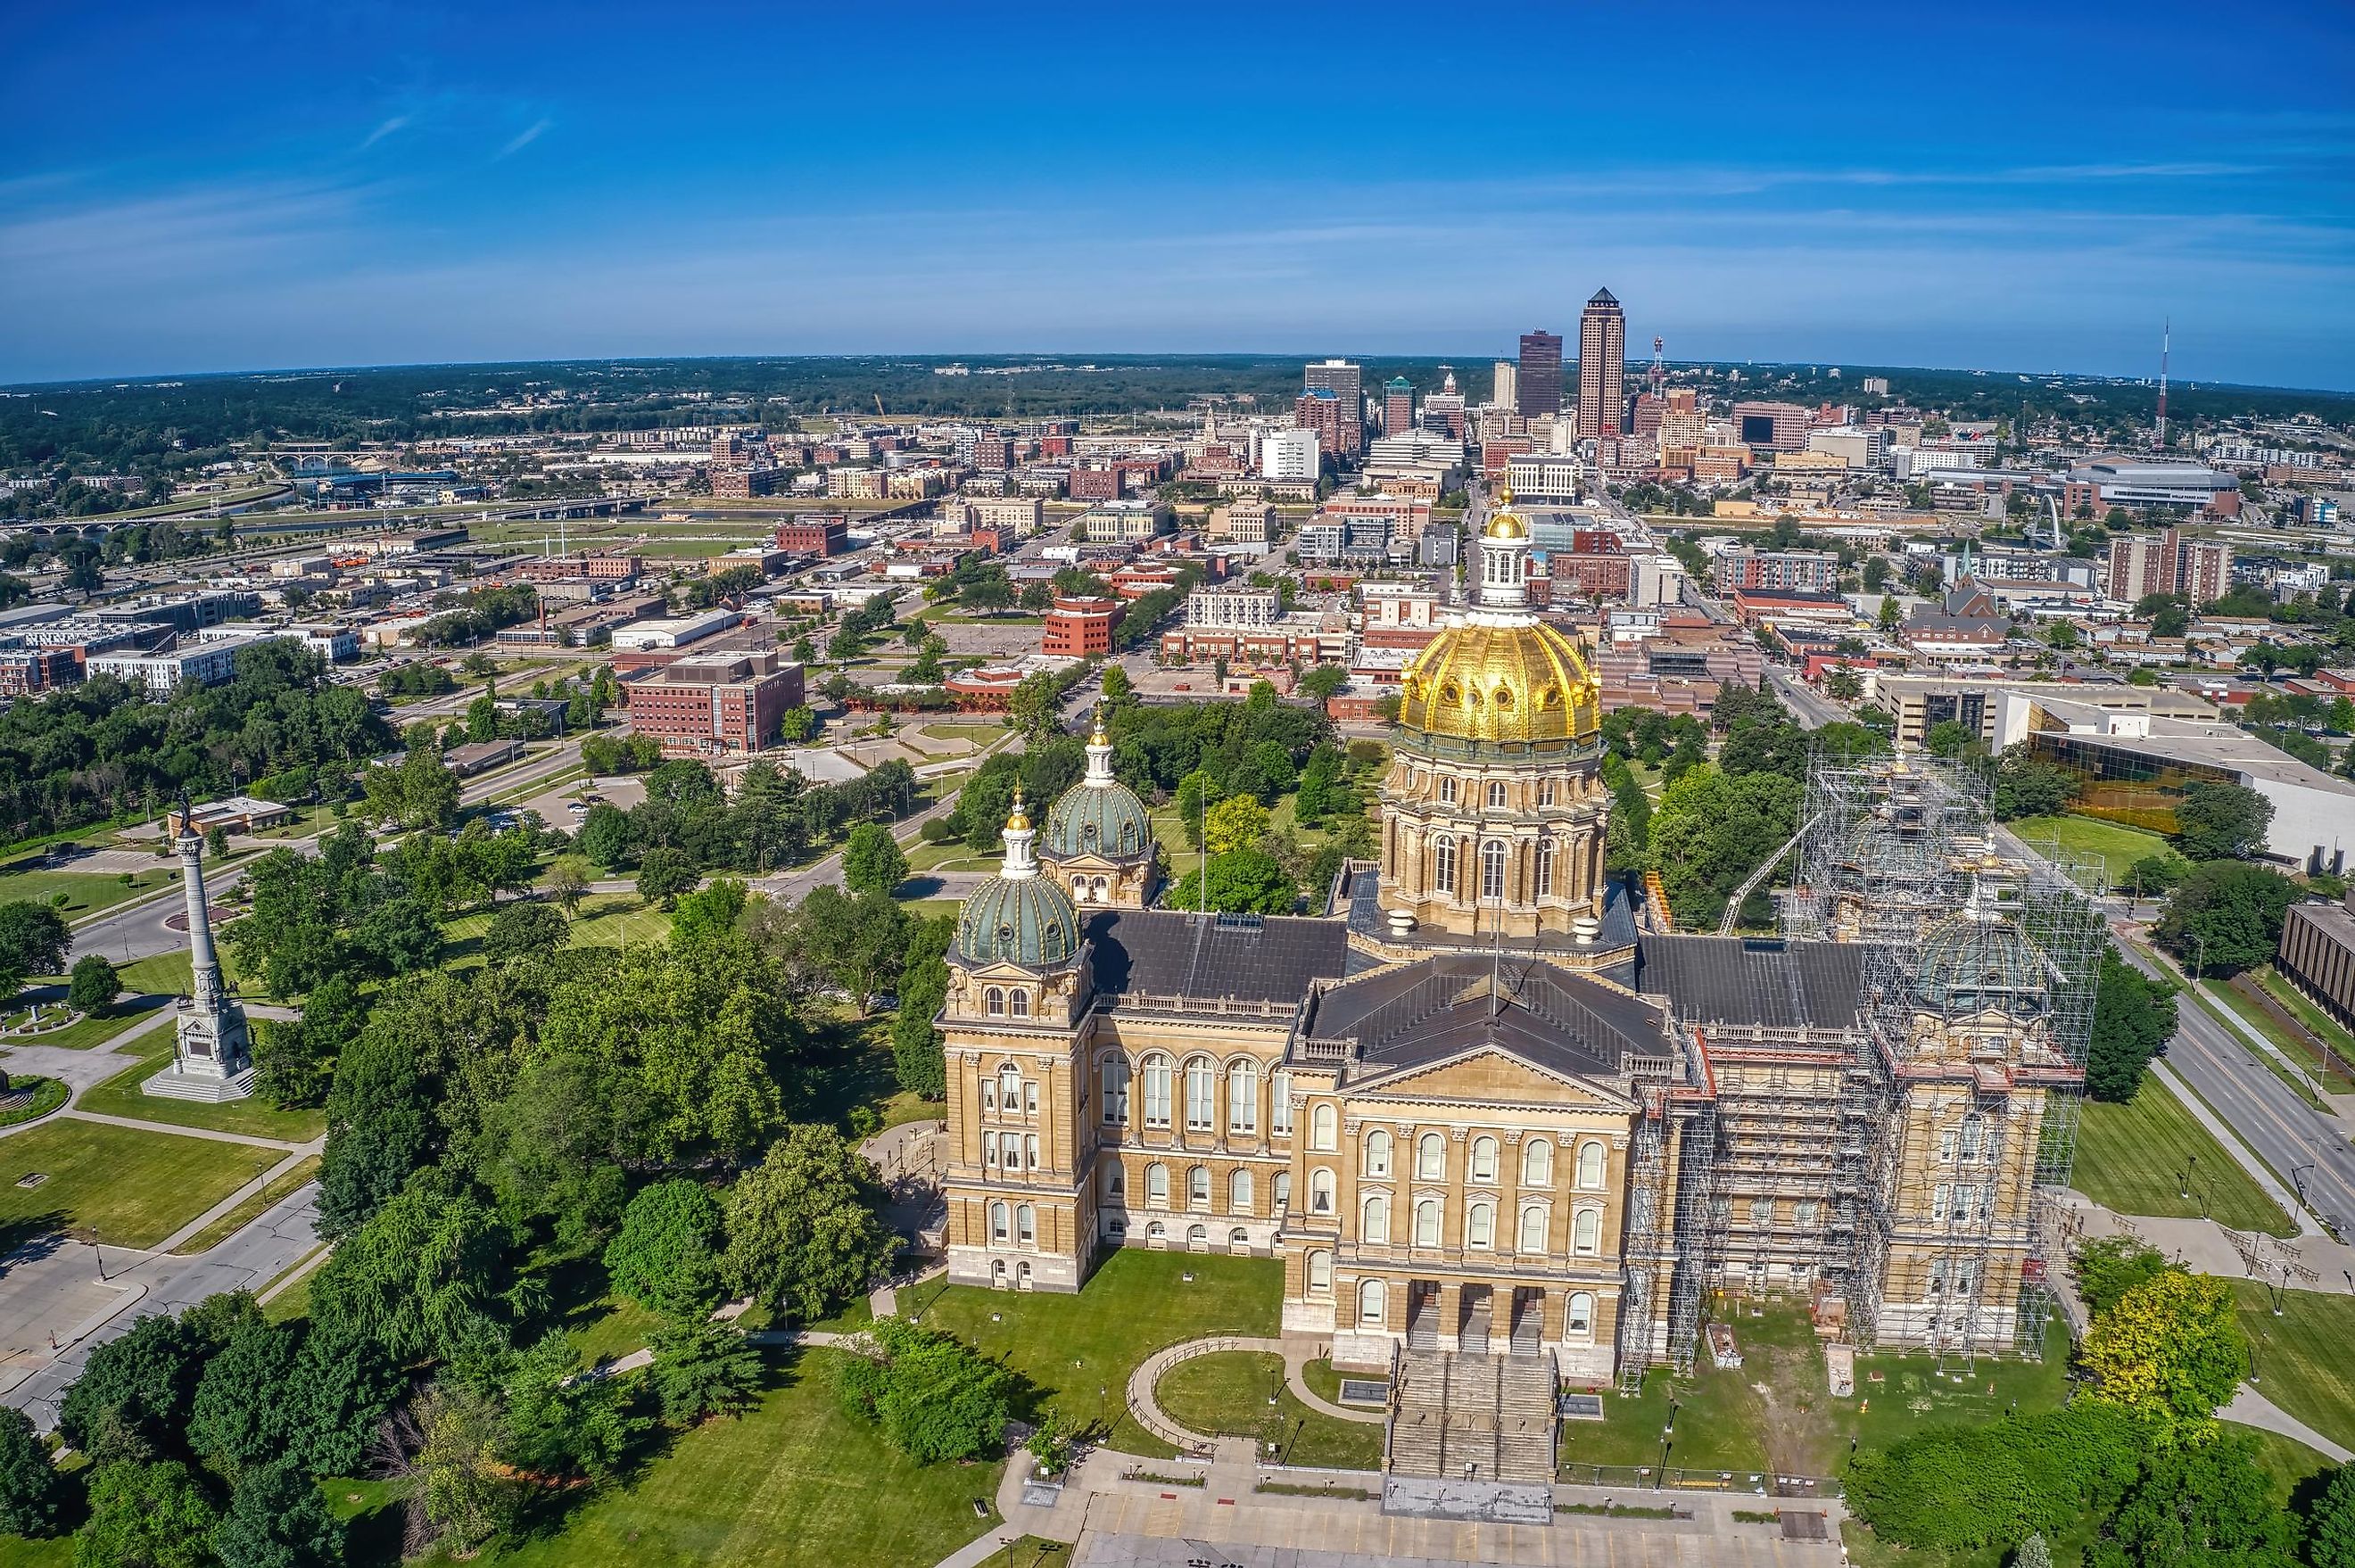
[723,1123,897,1321]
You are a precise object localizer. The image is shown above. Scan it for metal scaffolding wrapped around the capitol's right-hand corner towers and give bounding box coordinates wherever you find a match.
[1766,758,2105,1363]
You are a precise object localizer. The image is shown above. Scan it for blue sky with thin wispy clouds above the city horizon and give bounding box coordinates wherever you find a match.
[0,0,2355,389]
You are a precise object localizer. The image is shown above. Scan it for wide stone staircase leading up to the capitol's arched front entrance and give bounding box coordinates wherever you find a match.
[1387,1349,1554,1486]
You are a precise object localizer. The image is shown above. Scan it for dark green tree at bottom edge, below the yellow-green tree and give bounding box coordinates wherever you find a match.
[2084,1432,2299,1568]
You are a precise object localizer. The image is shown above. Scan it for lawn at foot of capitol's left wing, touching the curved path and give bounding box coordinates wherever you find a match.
[899,1248,1284,1457]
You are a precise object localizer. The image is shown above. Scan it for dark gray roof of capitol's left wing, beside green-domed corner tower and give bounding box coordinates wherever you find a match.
[1083,909,1350,1003]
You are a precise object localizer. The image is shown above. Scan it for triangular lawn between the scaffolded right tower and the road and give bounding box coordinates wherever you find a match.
[2070,1078,2296,1236]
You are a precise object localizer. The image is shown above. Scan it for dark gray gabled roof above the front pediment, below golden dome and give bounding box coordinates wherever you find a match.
[1305,953,1672,1078]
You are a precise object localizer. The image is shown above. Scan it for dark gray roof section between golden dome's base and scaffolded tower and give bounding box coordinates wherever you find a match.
[1634,935,1865,1029]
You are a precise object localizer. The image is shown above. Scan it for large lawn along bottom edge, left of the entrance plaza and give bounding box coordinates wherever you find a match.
[474,1349,998,1568]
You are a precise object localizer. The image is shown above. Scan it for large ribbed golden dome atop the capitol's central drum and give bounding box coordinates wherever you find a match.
[1399,617,1601,744]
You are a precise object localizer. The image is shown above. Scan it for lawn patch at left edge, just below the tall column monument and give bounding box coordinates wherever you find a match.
[0,1118,280,1248]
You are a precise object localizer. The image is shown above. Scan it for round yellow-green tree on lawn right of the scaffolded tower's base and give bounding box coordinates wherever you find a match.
[2082,1269,2249,1420]
